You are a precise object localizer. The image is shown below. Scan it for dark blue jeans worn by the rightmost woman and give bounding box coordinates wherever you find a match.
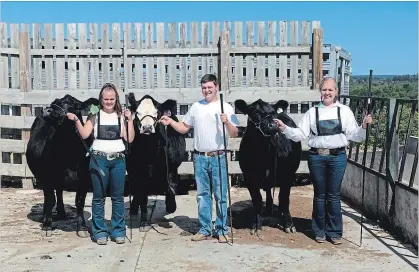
[307,151,346,238]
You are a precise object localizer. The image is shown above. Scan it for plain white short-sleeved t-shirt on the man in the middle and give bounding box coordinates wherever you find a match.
[183,99,239,152]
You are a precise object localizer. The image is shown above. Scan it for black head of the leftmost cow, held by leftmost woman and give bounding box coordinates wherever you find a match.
[42,94,99,125]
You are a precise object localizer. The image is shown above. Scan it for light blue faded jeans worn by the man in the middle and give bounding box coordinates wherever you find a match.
[193,154,228,236]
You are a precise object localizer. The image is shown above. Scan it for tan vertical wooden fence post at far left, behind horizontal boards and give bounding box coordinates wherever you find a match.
[19,32,33,189]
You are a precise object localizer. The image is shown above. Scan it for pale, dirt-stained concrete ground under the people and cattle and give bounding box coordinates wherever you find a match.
[0,185,418,272]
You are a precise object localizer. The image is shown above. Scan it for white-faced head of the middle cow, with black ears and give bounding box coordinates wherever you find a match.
[128,93,176,135]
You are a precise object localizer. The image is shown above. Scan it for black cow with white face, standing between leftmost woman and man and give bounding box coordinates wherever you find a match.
[127,93,186,232]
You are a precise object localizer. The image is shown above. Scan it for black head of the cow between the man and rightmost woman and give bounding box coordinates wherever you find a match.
[234,99,288,137]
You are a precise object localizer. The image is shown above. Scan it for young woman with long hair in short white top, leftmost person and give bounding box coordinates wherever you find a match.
[67,83,135,245]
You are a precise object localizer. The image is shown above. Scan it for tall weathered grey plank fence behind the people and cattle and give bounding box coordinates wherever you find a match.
[0,21,351,187]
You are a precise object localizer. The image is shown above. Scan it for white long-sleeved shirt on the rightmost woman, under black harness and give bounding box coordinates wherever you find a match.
[283,102,366,149]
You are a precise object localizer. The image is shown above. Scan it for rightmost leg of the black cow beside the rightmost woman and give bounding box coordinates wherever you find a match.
[278,174,296,233]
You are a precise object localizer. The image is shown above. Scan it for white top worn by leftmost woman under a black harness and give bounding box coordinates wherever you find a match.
[90,110,125,153]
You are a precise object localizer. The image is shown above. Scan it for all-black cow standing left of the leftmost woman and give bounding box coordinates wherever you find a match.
[26,95,99,238]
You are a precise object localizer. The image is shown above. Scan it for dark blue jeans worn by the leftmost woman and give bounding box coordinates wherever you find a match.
[90,154,126,240]
